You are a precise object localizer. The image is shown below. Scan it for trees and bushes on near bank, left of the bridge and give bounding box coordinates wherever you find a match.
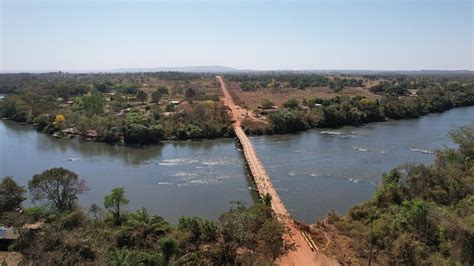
[0,168,285,265]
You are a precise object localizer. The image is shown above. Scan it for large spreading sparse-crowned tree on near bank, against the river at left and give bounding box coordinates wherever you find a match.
[28,168,89,211]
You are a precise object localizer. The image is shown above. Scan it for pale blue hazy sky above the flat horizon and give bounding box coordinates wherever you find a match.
[0,0,474,72]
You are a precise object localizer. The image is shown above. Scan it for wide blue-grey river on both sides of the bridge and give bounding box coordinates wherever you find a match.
[0,104,474,223]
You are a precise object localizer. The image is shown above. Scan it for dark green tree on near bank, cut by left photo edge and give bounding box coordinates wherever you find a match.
[0,176,26,212]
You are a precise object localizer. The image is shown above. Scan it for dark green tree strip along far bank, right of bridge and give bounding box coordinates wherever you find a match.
[244,83,474,134]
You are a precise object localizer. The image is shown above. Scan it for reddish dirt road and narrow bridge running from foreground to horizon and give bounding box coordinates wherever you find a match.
[217,76,339,265]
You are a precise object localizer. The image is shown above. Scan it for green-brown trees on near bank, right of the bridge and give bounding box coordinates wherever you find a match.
[327,127,474,265]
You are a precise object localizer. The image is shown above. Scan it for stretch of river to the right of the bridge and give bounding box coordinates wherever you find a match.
[251,107,474,223]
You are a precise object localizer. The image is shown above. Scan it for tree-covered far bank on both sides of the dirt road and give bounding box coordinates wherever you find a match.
[0,72,474,141]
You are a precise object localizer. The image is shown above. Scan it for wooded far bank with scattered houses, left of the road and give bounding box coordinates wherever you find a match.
[0,72,233,145]
